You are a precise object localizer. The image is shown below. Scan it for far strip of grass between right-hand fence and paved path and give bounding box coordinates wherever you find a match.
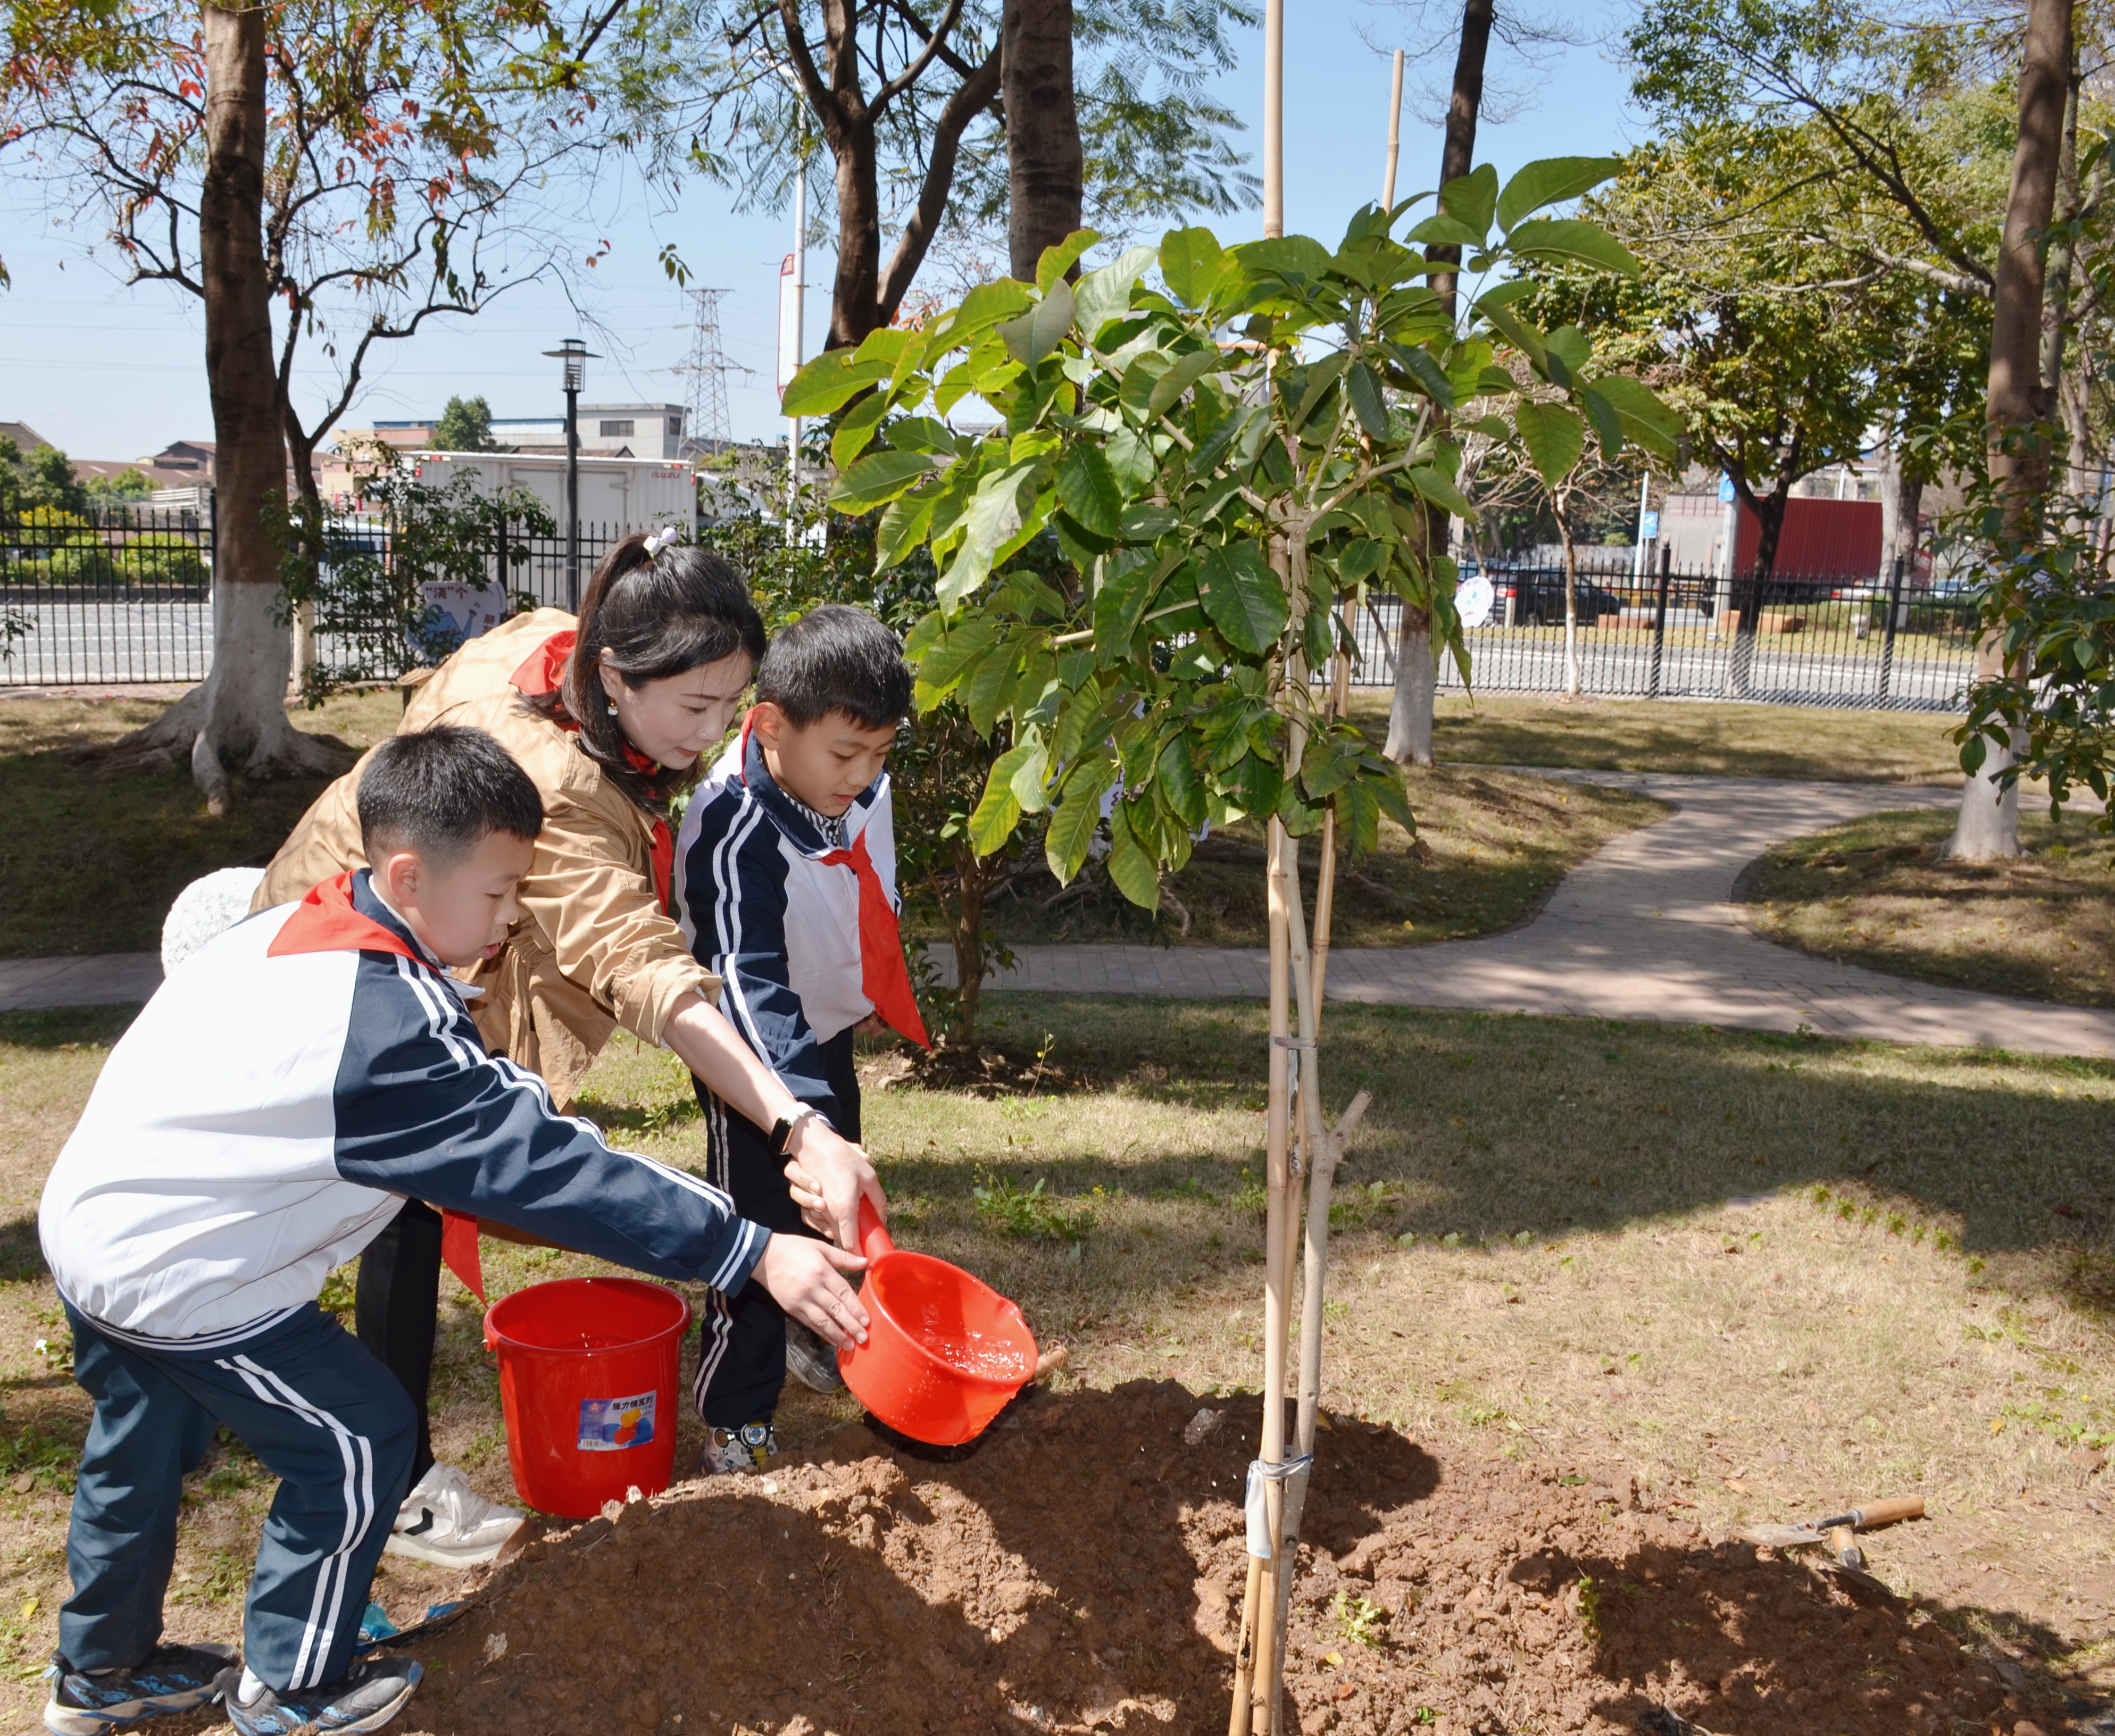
[1352,687,1961,784]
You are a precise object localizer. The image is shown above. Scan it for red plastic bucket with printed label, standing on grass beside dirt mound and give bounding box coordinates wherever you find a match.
[485,1277,689,1518]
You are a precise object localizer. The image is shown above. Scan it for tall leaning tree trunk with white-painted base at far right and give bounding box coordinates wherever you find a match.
[1946,0,2071,861]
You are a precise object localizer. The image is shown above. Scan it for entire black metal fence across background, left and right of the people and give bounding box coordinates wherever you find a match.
[0,510,1976,711]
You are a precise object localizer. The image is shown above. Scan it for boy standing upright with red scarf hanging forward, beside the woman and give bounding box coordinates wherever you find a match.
[675,603,926,1472]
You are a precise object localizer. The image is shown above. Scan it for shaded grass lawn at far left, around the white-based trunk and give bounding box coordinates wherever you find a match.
[0,694,402,958]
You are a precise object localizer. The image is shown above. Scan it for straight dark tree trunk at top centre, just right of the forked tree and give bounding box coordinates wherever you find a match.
[998,0,1085,283]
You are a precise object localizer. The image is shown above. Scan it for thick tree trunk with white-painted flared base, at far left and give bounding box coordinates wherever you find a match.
[112,0,347,814]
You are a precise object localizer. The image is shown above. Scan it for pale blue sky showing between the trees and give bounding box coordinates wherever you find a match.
[0,0,1643,459]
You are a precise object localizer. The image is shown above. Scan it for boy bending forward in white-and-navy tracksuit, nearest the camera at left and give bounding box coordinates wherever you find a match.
[38,728,865,1736]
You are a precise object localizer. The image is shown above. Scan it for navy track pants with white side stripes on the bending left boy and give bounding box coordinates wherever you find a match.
[59,1303,419,1692]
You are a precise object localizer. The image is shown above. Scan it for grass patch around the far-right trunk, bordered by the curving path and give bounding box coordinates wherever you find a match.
[1741,810,2115,1006]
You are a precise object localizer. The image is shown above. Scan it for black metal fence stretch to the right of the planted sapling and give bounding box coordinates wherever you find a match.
[1352,566,1978,711]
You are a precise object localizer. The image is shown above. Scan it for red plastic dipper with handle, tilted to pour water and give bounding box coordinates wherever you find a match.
[837,1201,1036,1446]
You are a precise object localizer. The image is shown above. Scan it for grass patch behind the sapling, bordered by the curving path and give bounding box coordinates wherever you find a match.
[986,765,1667,947]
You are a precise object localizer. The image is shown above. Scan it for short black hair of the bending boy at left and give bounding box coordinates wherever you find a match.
[357,723,544,873]
